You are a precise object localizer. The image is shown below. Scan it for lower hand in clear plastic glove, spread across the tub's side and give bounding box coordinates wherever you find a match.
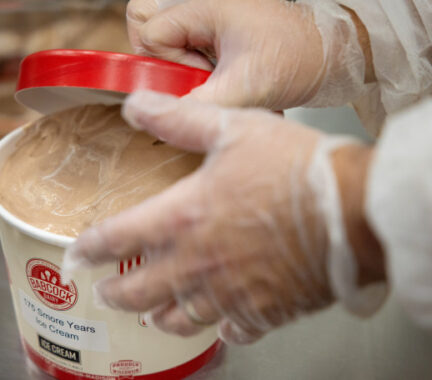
[64,92,384,343]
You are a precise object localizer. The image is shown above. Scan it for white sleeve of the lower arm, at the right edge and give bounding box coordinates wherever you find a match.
[366,99,432,328]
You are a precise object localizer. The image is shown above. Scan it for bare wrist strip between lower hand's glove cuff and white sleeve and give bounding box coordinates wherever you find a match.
[332,145,386,286]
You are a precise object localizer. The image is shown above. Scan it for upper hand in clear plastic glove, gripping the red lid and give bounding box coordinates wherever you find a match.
[127,0,368,110]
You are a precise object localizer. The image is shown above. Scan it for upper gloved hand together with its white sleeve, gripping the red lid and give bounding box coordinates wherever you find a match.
[128,0,432,135]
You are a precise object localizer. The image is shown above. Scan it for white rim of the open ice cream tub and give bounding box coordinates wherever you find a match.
[0,126,76,248]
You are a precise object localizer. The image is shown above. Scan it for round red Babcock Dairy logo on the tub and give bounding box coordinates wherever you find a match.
[26,259,78,310]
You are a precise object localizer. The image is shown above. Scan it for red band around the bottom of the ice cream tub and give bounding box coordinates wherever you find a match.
[22,339,222,380]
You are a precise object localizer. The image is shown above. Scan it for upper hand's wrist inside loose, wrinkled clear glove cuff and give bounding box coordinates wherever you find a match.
[296,0,374,107]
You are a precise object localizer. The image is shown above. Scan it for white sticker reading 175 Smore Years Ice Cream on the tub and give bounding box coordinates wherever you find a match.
[19,289,110,352]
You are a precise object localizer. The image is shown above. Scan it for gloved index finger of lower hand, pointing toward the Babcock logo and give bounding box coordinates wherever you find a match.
[63,175,201,277]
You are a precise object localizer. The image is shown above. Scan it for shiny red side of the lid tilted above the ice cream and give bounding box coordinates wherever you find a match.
[17,50,211,96]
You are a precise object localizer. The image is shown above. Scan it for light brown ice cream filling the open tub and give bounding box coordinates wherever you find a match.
[0,105,202,237]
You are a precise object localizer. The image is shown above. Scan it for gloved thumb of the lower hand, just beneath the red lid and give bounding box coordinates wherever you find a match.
[123,91,232,153]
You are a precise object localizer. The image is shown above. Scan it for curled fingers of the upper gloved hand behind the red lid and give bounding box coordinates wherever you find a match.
[127,0,214,70]
